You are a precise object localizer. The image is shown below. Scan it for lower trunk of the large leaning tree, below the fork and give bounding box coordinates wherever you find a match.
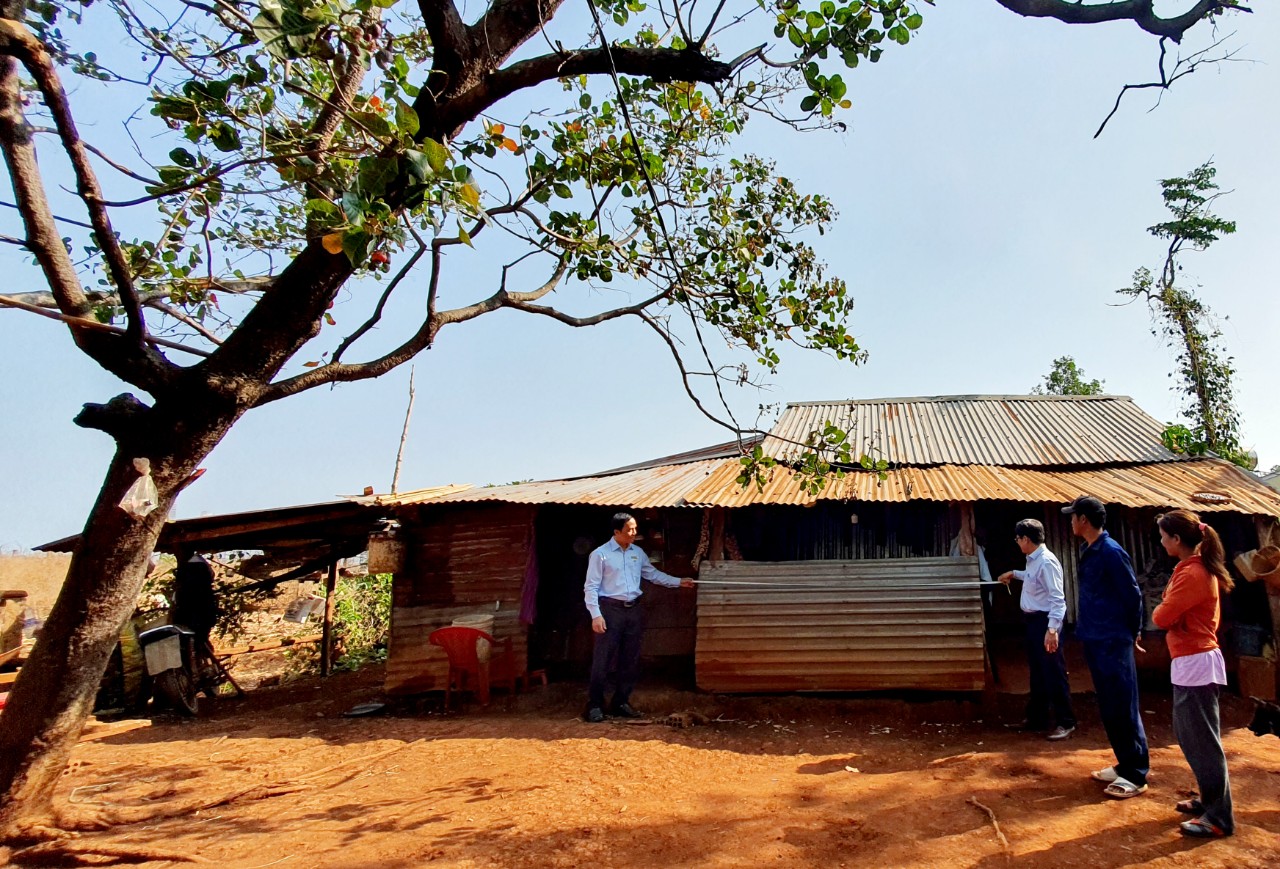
[0,417,230,841]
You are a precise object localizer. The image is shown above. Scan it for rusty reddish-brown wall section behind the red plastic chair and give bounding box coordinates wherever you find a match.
[387,504,535,694]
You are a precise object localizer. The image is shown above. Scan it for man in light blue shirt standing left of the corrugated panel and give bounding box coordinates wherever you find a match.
[584,513,694,724]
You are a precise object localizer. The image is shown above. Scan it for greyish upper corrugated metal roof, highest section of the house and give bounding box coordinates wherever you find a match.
[764,395,1179,467]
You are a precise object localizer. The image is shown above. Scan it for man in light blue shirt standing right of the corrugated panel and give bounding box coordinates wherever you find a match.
[998,520,1075,742]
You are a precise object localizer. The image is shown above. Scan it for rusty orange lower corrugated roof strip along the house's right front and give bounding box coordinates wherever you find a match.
[686,458,1280,516]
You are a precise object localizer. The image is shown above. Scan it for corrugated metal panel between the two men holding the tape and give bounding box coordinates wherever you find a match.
[696,558,984,694]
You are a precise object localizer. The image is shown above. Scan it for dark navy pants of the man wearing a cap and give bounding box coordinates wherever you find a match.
[1084,639,1151,786]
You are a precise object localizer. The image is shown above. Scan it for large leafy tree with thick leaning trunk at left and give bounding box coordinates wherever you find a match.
[0,0,1236,838]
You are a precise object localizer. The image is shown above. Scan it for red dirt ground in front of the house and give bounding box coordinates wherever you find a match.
[0,668,1280,869]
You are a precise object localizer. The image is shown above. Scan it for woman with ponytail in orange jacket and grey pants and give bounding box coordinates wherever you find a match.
[1151,509,1235,838]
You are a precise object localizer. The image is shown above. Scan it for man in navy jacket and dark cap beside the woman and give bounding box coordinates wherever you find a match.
[1062,495,1151,800]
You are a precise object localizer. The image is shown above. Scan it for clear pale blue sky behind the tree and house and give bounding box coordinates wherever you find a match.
[0,0,1280,549]
